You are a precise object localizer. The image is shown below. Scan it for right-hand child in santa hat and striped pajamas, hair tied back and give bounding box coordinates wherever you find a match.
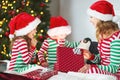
[79,0,120,80]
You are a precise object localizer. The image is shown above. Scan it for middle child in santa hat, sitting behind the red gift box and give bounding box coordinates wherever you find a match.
[38,16,79,68]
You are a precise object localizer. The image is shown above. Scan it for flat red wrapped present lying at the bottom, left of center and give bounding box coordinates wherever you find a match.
[23,69,58,80]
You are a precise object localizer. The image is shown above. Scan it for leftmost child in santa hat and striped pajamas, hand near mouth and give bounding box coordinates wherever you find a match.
[9,12,45,74]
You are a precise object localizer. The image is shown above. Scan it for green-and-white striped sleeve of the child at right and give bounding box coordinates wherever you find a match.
[98,40,120,73]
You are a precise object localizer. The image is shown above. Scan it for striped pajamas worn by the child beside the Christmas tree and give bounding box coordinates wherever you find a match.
[9,39,37,73]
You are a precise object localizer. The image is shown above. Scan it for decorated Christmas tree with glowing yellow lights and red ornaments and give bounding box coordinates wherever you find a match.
[0,0,51,59]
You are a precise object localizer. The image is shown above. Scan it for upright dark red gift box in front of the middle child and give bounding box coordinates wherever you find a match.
[54,47,84,72]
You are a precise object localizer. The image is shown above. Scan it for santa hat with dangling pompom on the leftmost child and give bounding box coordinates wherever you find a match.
[9,12,41,38]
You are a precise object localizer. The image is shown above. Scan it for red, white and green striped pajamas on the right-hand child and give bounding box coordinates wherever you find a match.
[87,31,120,74]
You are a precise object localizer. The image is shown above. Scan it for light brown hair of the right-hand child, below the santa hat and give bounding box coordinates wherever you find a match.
[96,21,119,41]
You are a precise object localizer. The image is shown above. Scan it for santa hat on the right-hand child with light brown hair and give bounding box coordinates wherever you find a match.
[87,0,115,21]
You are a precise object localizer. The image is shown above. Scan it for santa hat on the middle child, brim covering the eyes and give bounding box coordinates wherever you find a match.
[47,16,71,36]
